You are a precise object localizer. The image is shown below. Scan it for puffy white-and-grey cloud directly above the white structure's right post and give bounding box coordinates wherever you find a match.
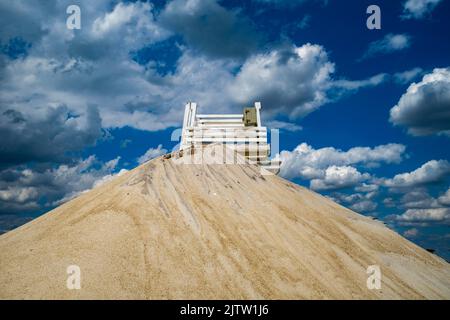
[230,44,334,118]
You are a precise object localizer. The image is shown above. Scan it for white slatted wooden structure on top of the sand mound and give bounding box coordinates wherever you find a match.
[180,102,281,174]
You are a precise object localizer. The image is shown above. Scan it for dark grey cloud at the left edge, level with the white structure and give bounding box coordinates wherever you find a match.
[0,106,102,168]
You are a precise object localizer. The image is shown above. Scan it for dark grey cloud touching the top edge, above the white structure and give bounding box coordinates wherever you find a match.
[159,0,259,58]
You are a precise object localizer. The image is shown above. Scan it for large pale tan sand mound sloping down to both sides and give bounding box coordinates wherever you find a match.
[0,148,450,299]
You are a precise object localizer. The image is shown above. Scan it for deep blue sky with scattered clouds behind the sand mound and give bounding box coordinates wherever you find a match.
[0,0,450,259]
